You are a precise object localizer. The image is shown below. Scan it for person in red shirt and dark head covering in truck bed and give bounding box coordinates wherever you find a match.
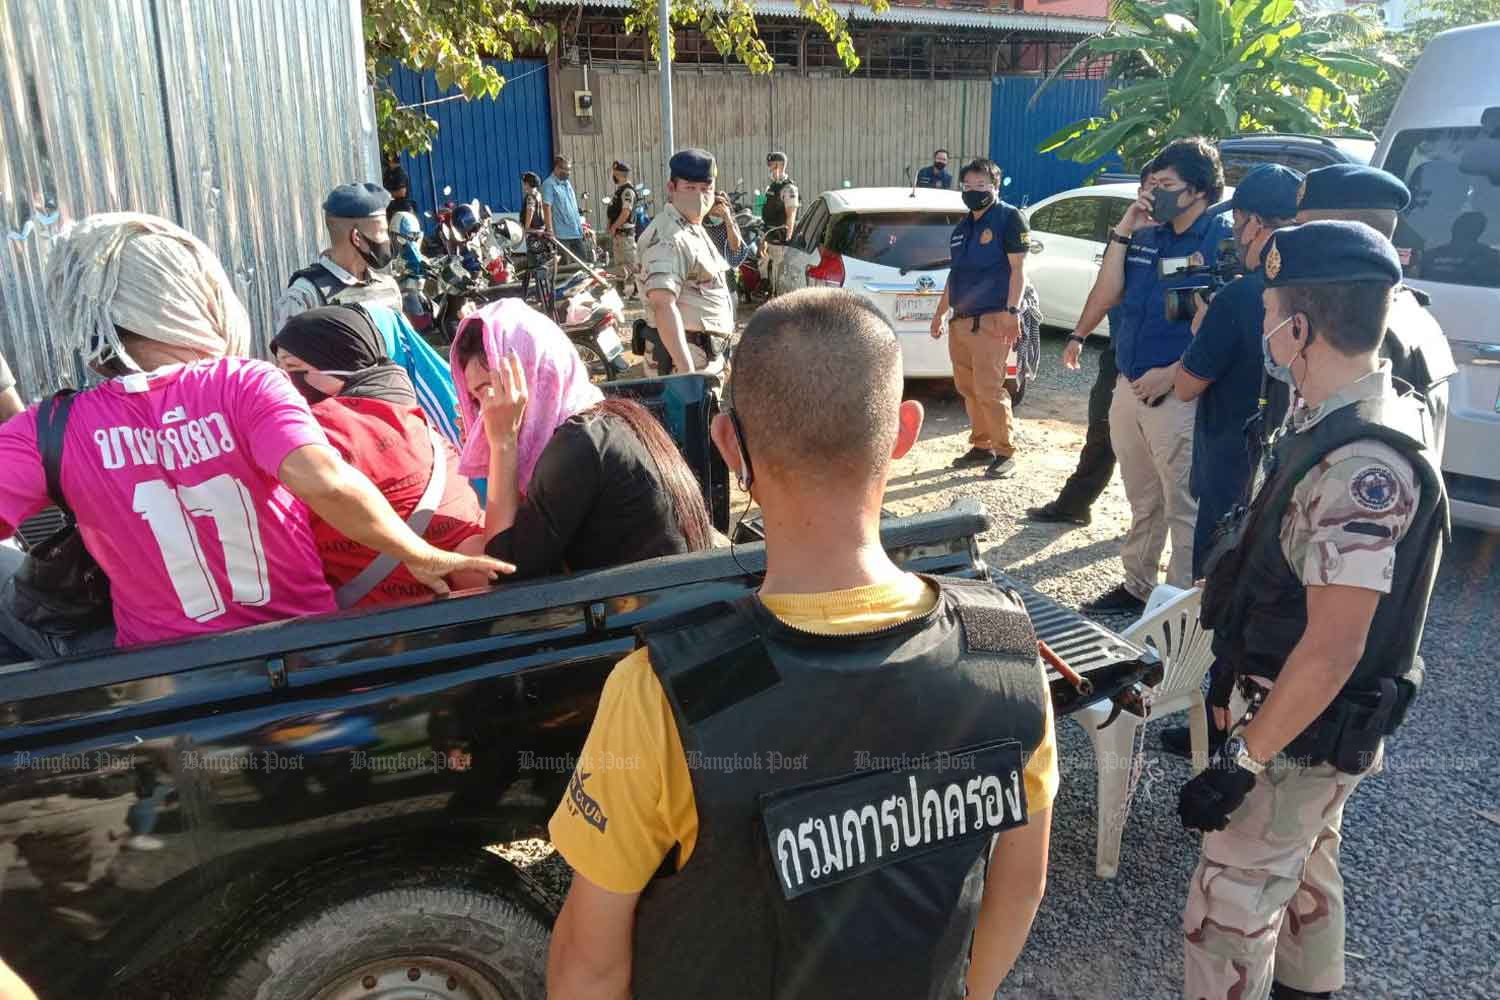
[272,306,486,607]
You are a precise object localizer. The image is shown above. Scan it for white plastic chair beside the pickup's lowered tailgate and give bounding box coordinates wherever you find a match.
[1074,586,1214,879]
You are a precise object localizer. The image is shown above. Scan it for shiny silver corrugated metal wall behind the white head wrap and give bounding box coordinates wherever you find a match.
[0,0,380,399]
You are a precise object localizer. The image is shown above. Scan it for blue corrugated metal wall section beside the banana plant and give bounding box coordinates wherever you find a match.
[990,76,1113,205]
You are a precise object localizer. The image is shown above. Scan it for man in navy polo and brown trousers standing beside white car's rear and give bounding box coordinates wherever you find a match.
[932,159,1029,480]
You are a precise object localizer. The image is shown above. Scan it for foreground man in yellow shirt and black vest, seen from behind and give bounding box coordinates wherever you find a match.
[548,289,1058,1000]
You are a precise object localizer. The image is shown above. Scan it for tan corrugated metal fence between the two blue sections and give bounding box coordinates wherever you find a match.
[558,66,990,225]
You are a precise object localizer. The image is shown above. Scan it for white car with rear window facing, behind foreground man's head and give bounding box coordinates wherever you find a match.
[782,187,1026,402]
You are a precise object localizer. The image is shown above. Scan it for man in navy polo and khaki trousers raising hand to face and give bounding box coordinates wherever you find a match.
[1080,138,1232,612]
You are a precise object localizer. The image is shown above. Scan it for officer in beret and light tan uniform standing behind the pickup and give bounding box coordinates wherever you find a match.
[639,148,735,375]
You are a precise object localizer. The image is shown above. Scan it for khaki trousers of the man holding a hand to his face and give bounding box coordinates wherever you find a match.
[1110,375,1199,601]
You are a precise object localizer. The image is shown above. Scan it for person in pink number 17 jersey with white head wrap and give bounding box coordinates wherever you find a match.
[0,213,512,657]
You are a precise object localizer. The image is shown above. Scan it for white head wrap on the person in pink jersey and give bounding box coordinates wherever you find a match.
[47,211,251,373]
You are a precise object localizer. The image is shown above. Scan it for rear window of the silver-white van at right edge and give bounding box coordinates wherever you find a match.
[1386,127,1500,288]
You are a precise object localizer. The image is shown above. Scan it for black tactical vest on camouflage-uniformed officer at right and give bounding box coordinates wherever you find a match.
[1203,394,1448,712]
